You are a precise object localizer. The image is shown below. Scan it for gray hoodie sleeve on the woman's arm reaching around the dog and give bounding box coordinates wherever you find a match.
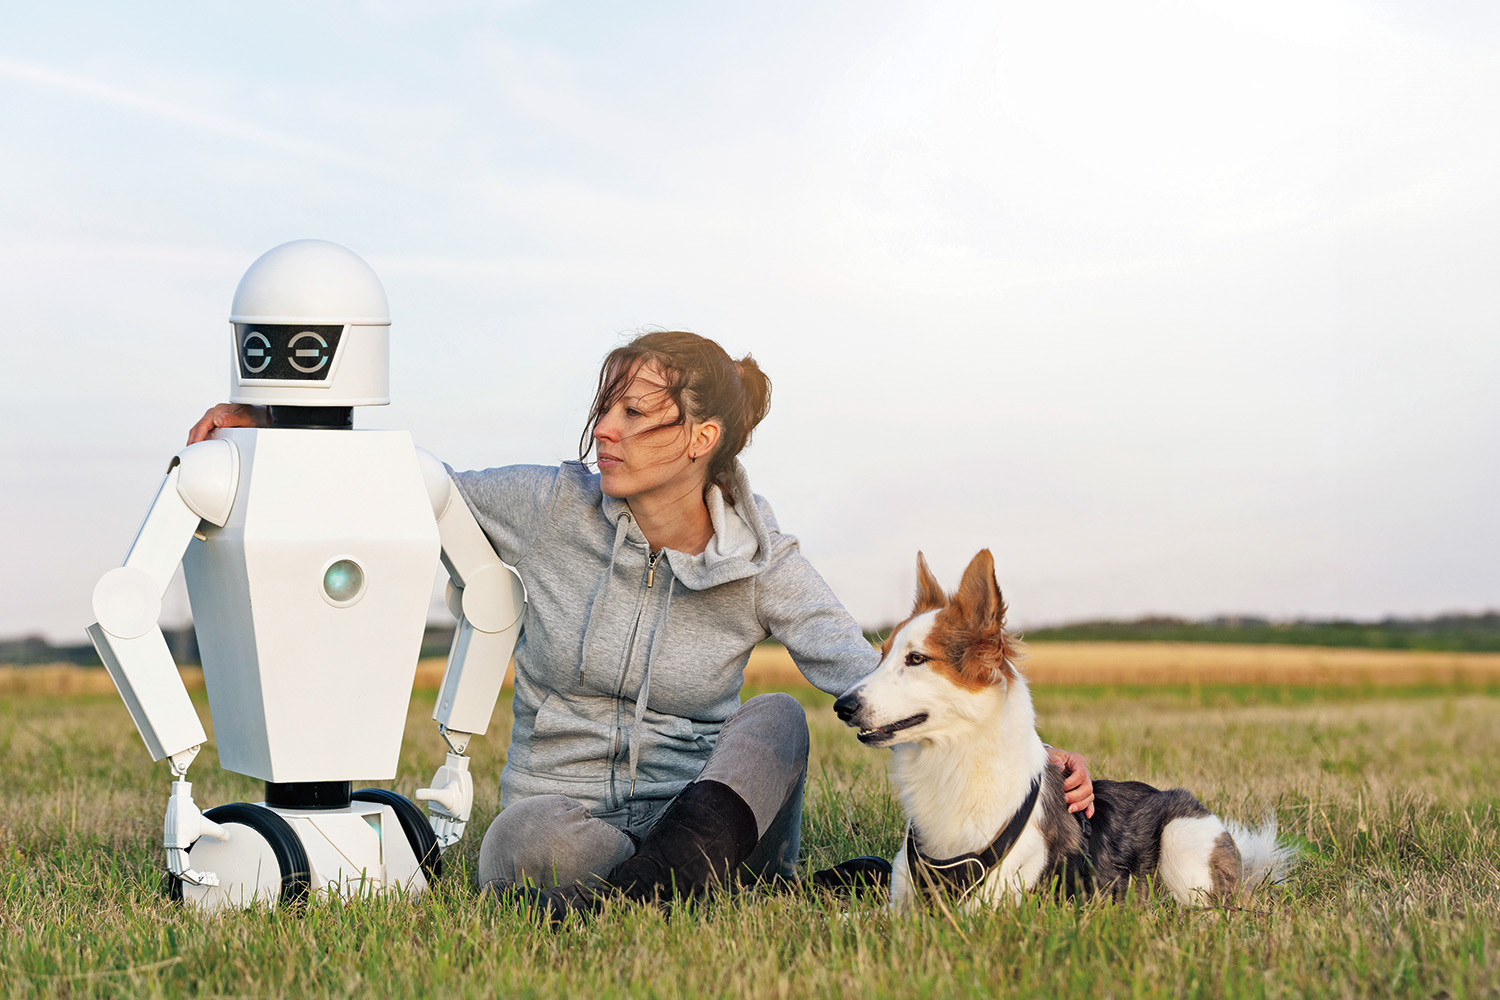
[756,535,881,694]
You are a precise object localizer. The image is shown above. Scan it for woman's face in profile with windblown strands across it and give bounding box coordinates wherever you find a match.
[594,363,708,499]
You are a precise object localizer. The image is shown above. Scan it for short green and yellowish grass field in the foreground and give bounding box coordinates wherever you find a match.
[0,685,1500,999]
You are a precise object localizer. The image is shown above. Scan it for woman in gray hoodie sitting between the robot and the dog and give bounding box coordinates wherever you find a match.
[189,331,1092,918]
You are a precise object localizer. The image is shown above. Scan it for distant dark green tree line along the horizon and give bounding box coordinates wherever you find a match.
[0,612,1500,667]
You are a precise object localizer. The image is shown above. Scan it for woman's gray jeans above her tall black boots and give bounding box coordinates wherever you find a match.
[479,694,807,888]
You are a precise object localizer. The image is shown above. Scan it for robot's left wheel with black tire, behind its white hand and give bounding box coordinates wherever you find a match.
[167,802,312,909]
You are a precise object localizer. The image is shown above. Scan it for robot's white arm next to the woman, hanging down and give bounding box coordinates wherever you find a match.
[417,448,527,849]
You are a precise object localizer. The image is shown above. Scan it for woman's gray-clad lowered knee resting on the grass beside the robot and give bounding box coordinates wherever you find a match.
[477,795,633,886]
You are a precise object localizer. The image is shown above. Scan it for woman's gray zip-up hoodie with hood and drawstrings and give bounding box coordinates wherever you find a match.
[455,462,879,813]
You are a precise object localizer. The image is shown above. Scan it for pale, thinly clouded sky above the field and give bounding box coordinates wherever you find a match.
[0,0,1500,643]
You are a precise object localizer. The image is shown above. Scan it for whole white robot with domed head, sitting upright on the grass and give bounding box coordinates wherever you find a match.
[89,240,525,910]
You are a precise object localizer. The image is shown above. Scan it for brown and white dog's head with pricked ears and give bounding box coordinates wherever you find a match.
[834,549,1020,747]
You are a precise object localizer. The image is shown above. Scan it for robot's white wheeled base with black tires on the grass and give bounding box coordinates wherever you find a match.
[171,789,443,913]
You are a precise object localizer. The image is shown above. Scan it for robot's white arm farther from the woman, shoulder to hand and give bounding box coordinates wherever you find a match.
[89,441,240,885]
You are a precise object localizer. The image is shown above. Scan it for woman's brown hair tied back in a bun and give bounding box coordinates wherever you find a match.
[578,330,771,504]
